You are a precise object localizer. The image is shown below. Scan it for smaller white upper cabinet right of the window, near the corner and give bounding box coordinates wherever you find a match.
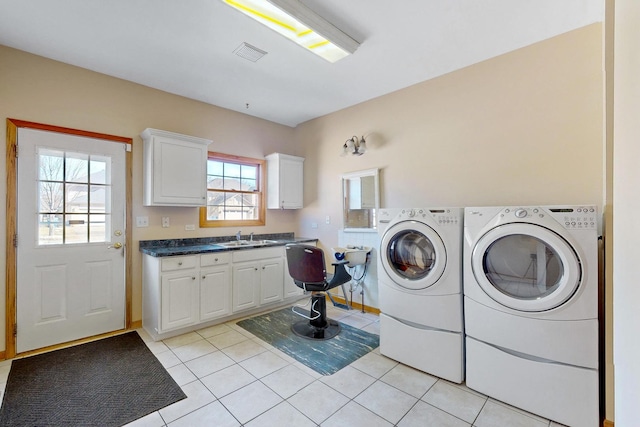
[265,153,304,209]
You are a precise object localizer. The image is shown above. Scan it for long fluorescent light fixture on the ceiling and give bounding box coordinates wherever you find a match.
[222,0,360,62]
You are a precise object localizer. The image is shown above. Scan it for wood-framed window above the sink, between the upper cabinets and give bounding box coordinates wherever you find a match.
[200,152,265,227]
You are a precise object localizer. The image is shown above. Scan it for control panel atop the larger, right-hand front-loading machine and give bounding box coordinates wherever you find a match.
[502,206,598,230]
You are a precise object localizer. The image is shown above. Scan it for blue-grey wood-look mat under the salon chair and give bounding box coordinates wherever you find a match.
[238,308,380,375]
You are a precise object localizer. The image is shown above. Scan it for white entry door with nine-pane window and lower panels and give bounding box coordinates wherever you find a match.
[16,128,126,353]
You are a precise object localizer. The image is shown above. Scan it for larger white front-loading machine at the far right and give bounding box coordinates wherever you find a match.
[463,206,599,427]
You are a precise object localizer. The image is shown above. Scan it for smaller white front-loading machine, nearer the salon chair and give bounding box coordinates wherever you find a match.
[378,208,464,383]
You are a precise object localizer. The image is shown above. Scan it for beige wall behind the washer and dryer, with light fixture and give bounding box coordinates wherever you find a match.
[295,24,604,258]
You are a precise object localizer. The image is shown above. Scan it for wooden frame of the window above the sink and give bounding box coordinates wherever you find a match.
[200,151,267,228]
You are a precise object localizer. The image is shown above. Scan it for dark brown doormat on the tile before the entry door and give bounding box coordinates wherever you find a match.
[0,332,186,427]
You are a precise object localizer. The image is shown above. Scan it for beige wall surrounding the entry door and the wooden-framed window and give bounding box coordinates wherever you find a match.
[0,46,301,349]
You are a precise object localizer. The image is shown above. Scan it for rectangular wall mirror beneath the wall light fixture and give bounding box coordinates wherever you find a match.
[342,169,380,231]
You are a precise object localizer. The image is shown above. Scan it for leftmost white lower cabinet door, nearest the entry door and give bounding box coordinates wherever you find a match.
[159,270,198,332]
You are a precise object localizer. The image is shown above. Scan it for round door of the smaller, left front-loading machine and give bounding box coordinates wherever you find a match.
[380,221,447,290]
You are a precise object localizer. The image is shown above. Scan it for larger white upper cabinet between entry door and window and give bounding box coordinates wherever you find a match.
[140,128,212,206]
